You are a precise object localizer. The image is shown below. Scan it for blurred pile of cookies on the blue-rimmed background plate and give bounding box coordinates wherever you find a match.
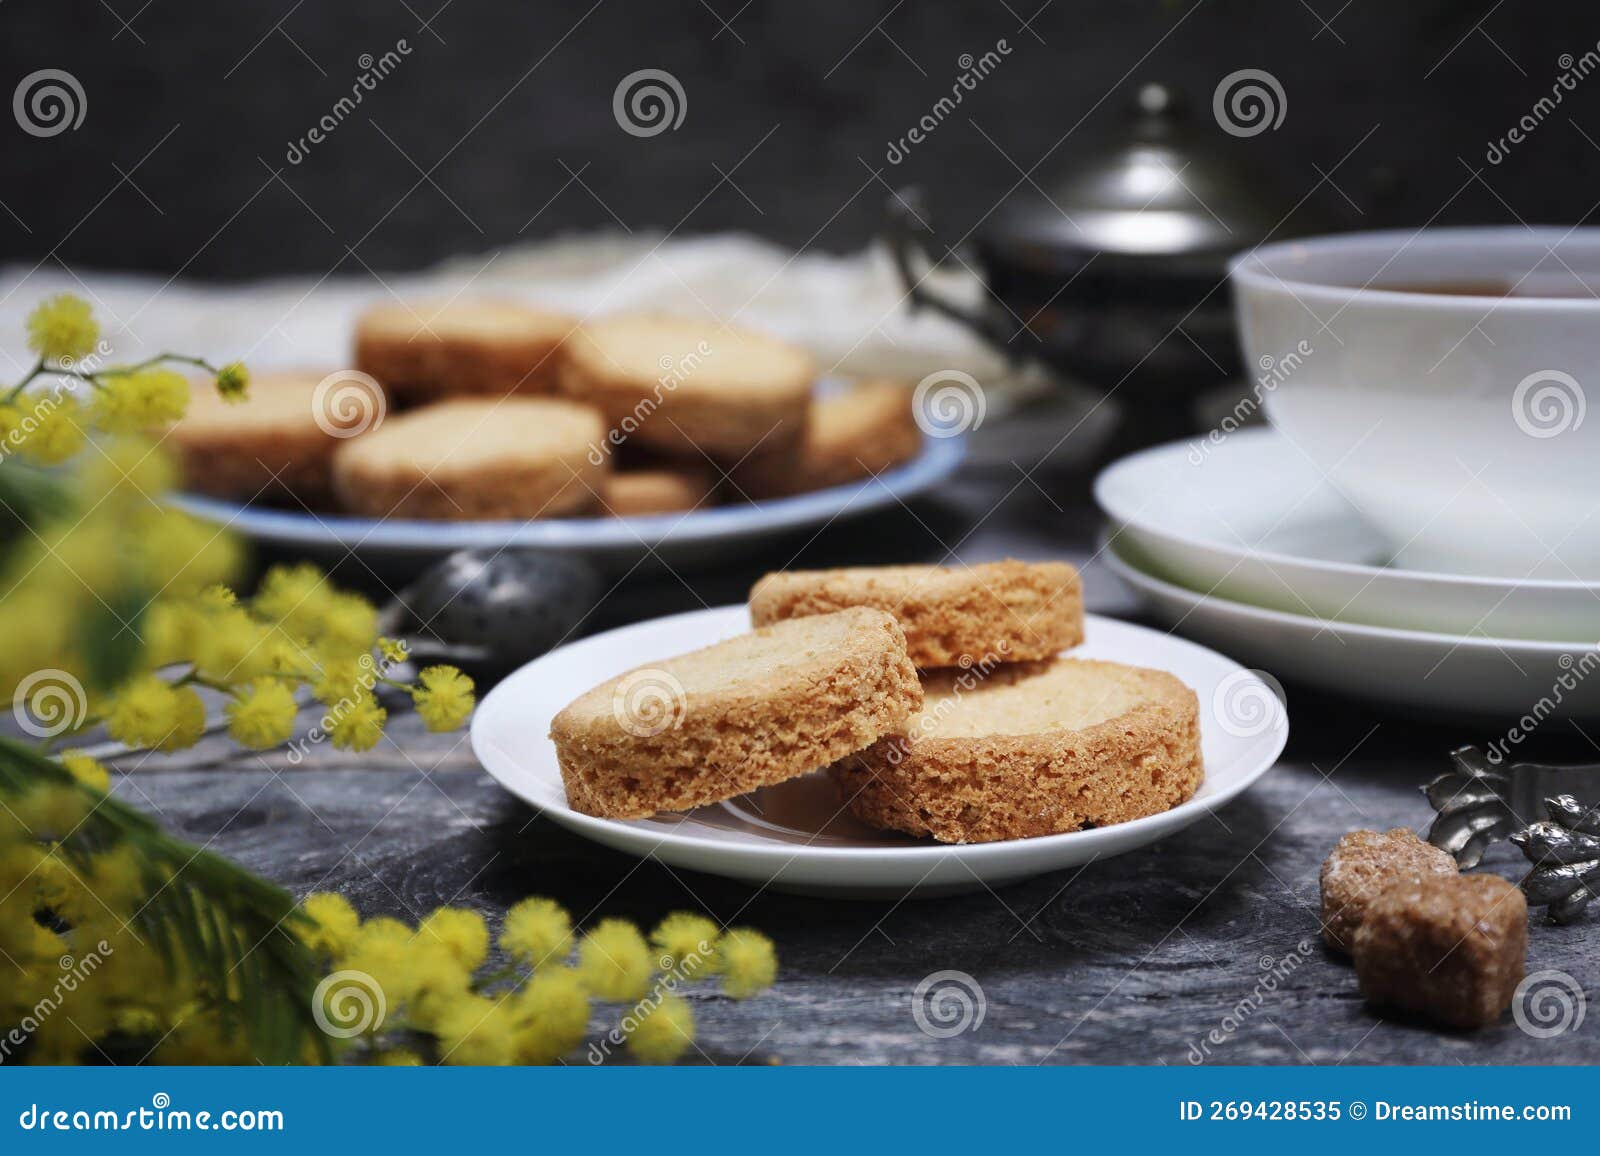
[170,301,922,520]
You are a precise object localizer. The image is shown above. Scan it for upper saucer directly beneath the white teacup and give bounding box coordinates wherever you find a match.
[1094,429,1600,642]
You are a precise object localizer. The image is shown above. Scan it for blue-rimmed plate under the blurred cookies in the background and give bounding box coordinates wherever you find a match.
[173,437,966,570]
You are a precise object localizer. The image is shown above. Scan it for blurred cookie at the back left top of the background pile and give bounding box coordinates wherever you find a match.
[355,301,578,405]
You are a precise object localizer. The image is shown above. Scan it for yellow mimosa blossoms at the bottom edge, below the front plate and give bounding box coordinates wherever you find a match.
[301,893,778,1065]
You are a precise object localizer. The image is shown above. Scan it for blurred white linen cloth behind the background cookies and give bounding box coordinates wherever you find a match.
[0,234,1010,389]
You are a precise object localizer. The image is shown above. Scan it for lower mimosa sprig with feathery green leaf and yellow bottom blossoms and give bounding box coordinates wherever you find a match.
[0,738,778,1065]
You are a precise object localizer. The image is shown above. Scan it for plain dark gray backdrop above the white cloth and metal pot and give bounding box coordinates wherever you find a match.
[0,0,1600,277]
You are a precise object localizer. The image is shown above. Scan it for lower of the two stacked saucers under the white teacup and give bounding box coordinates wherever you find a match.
[1101,540,1600,717]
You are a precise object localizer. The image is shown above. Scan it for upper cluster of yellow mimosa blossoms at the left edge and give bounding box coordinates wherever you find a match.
[0,295,474,753]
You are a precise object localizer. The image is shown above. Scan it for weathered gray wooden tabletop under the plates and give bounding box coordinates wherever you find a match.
[117,403,1600,1065]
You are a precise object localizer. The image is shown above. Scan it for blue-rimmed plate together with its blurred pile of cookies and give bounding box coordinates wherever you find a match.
[166,301,962,567]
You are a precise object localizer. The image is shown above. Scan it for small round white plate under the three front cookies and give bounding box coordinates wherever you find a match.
[472,605,1288,898]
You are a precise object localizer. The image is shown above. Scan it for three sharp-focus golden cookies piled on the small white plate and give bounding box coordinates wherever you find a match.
[550,562,1203,842]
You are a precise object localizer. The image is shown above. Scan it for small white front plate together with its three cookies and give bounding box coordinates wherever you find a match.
[472,560,1288,898]
